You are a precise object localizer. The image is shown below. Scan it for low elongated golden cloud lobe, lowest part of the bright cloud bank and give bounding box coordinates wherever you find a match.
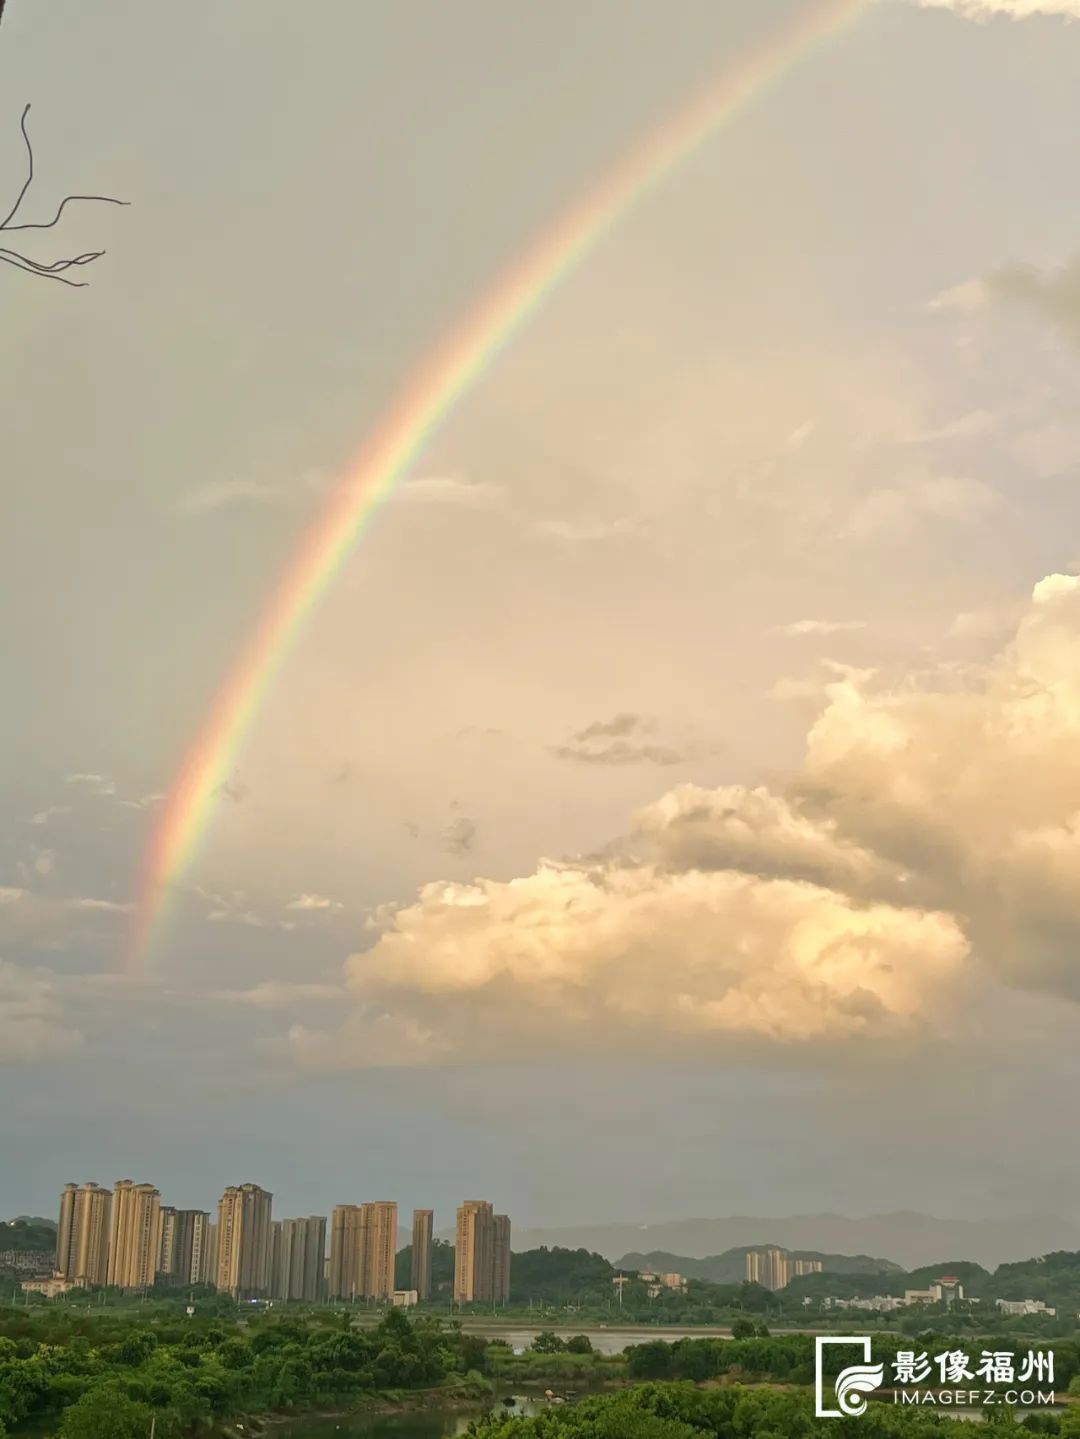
[316,863,966,1063]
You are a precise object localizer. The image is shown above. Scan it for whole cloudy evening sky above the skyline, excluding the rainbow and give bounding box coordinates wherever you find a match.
[0,0,1080,1227]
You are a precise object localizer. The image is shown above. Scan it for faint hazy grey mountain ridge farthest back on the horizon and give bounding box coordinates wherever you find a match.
[513,1210,1080,1269]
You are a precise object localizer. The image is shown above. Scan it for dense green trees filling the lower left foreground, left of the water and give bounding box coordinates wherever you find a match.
[0,1307,485,1439]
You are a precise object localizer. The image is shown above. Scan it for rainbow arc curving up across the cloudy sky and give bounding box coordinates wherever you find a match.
[127,0,867,973]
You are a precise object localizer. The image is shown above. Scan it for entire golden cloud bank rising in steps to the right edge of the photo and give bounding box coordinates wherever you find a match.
[300,574,1080,1065]
